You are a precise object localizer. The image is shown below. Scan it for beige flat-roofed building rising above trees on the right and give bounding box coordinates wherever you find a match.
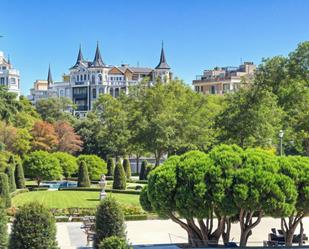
[192,62,256,94]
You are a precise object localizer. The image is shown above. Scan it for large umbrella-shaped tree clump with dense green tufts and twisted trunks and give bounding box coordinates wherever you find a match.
[140,145,300,246]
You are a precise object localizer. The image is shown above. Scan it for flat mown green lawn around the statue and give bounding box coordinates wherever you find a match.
[12,191,140,208]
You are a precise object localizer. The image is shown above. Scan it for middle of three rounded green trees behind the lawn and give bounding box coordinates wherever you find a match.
[52,152,78,179]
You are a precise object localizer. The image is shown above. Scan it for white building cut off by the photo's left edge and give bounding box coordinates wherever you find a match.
[0,51,20,97]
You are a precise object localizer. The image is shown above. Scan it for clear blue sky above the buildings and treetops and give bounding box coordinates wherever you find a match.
[0,0,309,94]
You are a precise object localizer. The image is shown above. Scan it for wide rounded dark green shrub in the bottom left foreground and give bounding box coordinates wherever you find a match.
[9,203,59,249]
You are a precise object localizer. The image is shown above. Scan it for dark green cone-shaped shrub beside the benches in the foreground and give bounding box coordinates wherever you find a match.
[93,196,125,249]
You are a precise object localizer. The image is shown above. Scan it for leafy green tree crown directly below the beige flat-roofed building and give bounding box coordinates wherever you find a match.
[216,87,282,148]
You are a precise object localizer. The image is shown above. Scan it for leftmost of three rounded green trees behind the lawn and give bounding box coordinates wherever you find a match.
[23,151,62,186]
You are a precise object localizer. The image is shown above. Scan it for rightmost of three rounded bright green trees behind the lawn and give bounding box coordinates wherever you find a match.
[77,155,107,180]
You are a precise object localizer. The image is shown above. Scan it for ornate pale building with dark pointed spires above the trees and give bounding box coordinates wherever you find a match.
[29,44,172,117]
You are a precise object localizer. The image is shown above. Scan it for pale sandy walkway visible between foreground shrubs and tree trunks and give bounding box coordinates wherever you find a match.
[53,218,309,249]
